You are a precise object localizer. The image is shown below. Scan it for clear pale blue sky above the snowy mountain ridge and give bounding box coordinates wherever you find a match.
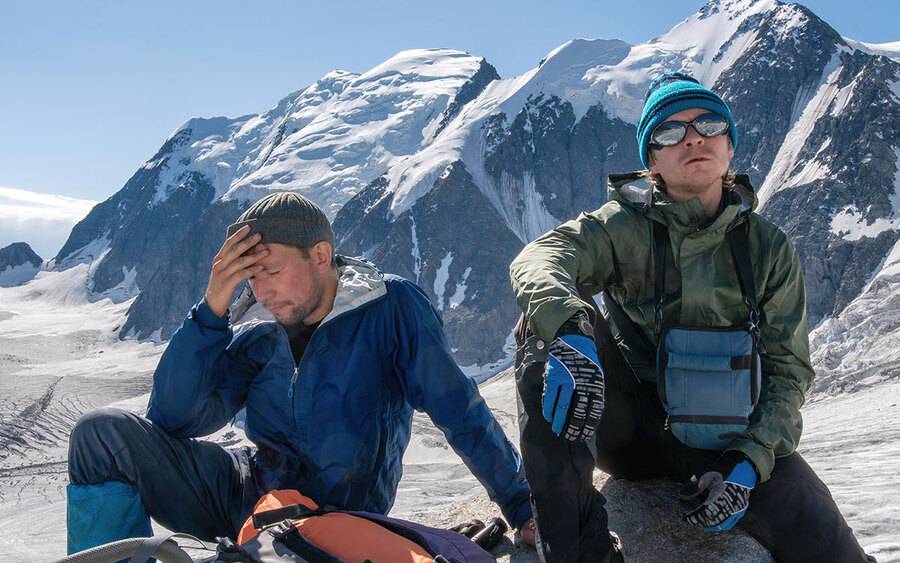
[0,0,900,200]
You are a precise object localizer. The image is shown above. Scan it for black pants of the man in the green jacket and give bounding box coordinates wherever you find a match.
[516,321,867,563]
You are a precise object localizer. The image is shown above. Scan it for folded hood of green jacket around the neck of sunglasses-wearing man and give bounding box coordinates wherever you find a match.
[607,172,758,228]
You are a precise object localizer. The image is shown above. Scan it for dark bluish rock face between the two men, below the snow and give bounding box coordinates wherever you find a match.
[334,162,521,365]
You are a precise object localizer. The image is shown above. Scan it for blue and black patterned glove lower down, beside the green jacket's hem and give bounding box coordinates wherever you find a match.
[681,450,756,532]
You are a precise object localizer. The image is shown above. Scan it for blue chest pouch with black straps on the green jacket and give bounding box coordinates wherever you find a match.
[653,220,762,450]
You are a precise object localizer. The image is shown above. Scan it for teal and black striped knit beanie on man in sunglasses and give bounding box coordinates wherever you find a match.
[637,72,738,168]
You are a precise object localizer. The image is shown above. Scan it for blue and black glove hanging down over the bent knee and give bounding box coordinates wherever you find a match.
[543,334,604,441]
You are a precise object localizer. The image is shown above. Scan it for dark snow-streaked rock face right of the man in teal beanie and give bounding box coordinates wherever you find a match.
[764,52,900,323]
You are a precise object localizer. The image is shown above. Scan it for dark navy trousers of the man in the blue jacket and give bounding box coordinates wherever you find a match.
[69,408,261,540]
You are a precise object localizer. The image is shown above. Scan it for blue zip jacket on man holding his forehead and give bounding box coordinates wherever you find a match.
[147,258,531,527]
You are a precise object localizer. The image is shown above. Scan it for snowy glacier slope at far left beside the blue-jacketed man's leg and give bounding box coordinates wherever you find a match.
[0,264,163,562]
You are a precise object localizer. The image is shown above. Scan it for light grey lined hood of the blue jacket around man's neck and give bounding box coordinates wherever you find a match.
[231,255,387,324]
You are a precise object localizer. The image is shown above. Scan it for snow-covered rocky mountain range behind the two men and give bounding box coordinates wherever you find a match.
[56,0,900,371]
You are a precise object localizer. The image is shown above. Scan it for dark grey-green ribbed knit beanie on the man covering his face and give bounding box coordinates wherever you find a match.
[227,192,334,248]
